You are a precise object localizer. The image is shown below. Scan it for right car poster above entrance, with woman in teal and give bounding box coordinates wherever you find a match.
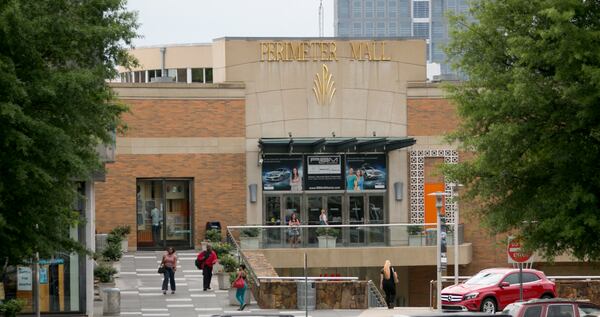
[346,154,387,191]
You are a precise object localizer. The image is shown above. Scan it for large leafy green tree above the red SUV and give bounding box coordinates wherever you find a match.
[445,0,600,260]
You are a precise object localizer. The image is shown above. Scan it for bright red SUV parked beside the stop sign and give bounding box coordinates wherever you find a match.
[441,268,556,313]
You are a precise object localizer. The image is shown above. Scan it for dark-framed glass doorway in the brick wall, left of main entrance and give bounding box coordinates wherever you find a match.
[136,178,194,250]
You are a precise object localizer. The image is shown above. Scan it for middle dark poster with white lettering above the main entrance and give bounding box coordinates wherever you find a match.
[306,155,344,190]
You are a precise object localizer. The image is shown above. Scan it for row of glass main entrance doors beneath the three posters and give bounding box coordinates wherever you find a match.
[263,191,387,248]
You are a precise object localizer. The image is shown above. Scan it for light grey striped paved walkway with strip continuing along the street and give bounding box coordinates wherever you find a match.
[94,250,431,317]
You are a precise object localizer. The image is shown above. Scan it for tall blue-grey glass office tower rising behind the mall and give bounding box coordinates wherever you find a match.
[334,0,469,78]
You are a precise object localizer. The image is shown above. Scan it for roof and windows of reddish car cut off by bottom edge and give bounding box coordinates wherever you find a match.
[502,298,600,317]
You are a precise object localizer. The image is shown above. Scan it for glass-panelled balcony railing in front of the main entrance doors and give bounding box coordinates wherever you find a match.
[227,223,464,249]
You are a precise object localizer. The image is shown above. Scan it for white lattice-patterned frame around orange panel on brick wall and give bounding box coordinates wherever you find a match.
[409,150,458,223]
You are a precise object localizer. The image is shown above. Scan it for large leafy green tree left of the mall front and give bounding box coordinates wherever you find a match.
[0,0,137,263]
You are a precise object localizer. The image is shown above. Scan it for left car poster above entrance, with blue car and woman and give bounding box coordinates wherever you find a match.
[262,155,304,191]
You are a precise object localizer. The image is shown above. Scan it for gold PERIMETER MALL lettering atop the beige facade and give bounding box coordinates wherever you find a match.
[260,41,392,62]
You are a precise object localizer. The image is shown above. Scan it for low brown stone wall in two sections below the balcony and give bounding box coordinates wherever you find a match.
[254,280,369,309]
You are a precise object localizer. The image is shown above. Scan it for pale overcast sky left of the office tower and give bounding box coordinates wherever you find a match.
[128,0,333,47]
